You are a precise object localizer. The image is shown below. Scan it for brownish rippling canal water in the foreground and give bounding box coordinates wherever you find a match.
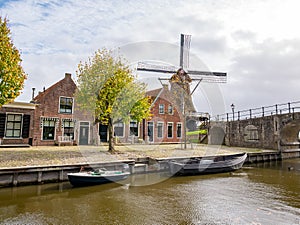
[0,159,300,225]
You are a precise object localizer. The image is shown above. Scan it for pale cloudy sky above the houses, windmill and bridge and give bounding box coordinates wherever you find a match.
[0,0,300,114]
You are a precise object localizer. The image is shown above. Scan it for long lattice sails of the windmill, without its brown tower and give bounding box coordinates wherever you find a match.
[137,34,227,149]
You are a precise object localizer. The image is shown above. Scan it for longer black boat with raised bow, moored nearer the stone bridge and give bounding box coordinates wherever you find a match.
[169,153,247,175]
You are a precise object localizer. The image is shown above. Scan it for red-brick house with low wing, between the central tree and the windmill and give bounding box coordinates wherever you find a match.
[109,85,183,144]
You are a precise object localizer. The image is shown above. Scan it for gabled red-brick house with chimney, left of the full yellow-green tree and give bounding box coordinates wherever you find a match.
[32,73,95,145]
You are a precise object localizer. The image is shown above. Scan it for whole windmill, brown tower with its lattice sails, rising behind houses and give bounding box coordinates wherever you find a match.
[137,34,227,149]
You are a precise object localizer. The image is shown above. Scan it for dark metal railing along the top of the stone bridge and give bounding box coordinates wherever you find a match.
[211,101,300,121]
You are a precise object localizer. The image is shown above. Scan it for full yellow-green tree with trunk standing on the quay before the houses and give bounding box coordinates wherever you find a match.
[75,49,151,152]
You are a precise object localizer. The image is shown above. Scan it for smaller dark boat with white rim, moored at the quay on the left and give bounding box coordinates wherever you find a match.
[68,170,130,186]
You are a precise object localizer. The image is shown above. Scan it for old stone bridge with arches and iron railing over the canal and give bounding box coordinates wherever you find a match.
[208,102,300,151]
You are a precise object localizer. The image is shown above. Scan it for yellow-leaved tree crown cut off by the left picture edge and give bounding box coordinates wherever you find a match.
[0,17,27,106]
